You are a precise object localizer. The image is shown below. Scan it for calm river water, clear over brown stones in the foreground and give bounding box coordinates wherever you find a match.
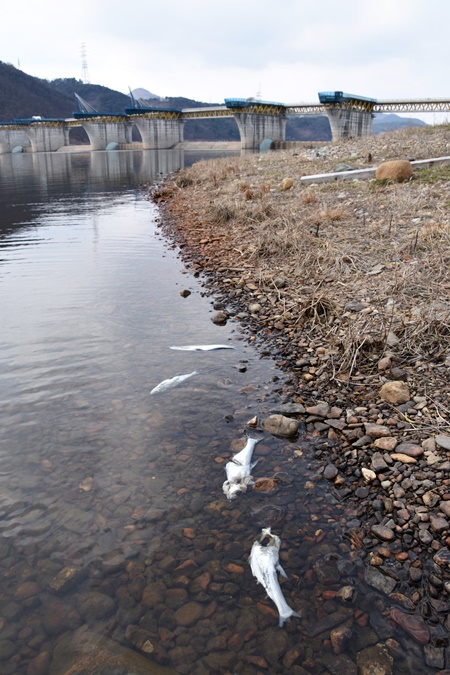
[0,151,434,675]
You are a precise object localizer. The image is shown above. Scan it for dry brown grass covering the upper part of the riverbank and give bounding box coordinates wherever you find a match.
[156,126,450,386]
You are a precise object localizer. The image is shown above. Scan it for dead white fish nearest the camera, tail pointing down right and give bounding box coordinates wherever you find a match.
[248,527,300,627]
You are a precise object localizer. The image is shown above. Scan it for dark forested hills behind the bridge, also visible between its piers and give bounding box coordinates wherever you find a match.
[0,61,425,141]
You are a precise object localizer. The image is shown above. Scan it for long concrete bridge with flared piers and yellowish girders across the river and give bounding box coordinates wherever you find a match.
[0,91,450,154]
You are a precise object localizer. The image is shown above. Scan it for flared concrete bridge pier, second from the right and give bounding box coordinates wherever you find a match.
[233,112,286,150]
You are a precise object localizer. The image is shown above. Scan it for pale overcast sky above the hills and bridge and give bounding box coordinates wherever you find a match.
[0,0,450,117]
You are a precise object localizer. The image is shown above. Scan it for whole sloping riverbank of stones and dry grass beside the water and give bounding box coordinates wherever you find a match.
[151,127,450,672]
